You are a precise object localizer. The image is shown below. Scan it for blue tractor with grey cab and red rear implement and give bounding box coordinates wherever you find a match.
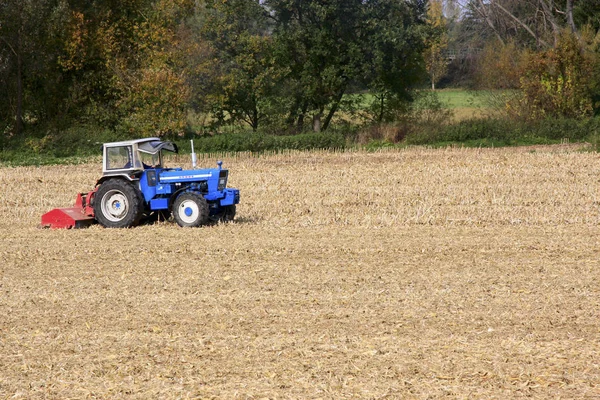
[42,138,240,228]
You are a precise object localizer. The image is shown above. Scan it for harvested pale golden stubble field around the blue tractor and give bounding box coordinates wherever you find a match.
[0,146,600,399]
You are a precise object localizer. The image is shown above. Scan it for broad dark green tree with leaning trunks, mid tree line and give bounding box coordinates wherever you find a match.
[264,0,424,132]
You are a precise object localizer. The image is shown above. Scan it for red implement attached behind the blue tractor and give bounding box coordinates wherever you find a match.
[42,189,96,229]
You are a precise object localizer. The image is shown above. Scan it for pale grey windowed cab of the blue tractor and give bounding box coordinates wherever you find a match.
[102,138,178,176]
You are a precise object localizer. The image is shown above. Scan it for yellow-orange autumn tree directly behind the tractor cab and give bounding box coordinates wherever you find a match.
[116,0,193,136]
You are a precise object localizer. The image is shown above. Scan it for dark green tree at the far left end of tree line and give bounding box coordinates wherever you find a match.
[0,0,65,135]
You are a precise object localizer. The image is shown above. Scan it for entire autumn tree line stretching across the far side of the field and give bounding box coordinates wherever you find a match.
[0,0,600,142]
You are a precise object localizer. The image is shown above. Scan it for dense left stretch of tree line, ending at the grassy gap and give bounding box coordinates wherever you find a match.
[0,0,430,135]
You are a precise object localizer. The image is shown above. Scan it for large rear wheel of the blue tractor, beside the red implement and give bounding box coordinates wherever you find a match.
[94,179,143,228]
